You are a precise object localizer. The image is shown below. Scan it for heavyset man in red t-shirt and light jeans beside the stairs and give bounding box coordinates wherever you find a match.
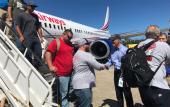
[45,29,73,107]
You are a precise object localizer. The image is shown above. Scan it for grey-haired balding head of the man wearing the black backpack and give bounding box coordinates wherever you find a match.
[145,25,160,39]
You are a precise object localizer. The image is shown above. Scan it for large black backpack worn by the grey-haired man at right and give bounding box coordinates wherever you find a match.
[121,41,164,87]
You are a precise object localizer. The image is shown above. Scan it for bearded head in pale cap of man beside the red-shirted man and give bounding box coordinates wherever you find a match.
[76,38,90,52]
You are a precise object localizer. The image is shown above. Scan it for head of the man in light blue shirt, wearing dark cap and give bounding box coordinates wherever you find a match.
[109,34,121,47]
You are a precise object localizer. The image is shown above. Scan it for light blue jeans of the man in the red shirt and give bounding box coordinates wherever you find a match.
[59,76,70,107]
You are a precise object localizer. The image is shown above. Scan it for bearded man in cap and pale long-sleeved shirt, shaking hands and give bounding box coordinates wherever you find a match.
[72,39,105,107]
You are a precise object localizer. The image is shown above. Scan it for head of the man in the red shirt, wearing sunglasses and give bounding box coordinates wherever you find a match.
[62,29,73,43]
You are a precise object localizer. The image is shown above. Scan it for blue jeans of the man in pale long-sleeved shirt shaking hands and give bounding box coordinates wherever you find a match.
[74,88,92,107]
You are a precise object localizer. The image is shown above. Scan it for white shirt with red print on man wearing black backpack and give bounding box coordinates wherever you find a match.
[138,39,170,89]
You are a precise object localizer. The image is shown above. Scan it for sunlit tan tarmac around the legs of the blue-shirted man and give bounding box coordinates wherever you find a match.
[93,69,144,107]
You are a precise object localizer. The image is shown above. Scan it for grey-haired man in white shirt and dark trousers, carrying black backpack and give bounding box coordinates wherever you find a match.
[138,25,170,107]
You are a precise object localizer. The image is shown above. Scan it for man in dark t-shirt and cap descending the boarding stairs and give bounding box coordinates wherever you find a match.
[16,2,42,67]
